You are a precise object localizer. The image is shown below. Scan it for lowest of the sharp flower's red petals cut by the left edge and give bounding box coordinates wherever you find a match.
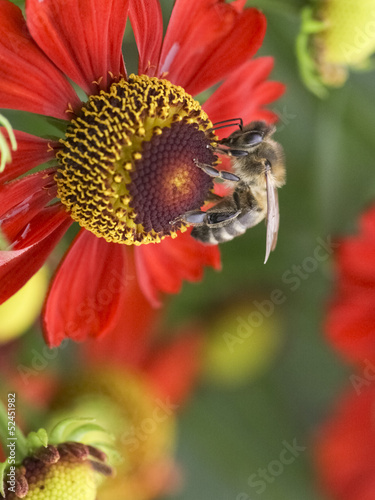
[0,205,72,303]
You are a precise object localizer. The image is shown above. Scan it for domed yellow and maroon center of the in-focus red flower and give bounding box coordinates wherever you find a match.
[56,75,217,245]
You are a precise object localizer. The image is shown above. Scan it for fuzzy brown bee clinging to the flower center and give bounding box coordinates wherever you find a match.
[179,119,285,263]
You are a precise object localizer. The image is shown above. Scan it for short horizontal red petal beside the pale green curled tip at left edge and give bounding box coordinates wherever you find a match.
[0,127,58,183]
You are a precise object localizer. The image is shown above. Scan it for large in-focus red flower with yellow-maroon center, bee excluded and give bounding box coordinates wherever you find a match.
[0,0,283,346]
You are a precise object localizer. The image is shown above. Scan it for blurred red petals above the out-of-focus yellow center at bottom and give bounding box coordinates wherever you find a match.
[80,266,204,405]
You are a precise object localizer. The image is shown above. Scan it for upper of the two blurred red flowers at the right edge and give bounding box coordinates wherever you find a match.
[326,203,375,362]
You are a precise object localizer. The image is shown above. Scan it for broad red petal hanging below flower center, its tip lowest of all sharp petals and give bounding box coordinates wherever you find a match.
[44,230,128,347]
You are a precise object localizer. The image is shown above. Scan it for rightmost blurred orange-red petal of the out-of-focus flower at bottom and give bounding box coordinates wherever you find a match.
[143,331,203,404]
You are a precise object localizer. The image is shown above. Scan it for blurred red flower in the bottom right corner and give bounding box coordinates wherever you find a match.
[316,384,375,500]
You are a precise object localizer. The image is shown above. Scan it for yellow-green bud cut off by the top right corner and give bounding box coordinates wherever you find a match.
[297,0,375,96]
